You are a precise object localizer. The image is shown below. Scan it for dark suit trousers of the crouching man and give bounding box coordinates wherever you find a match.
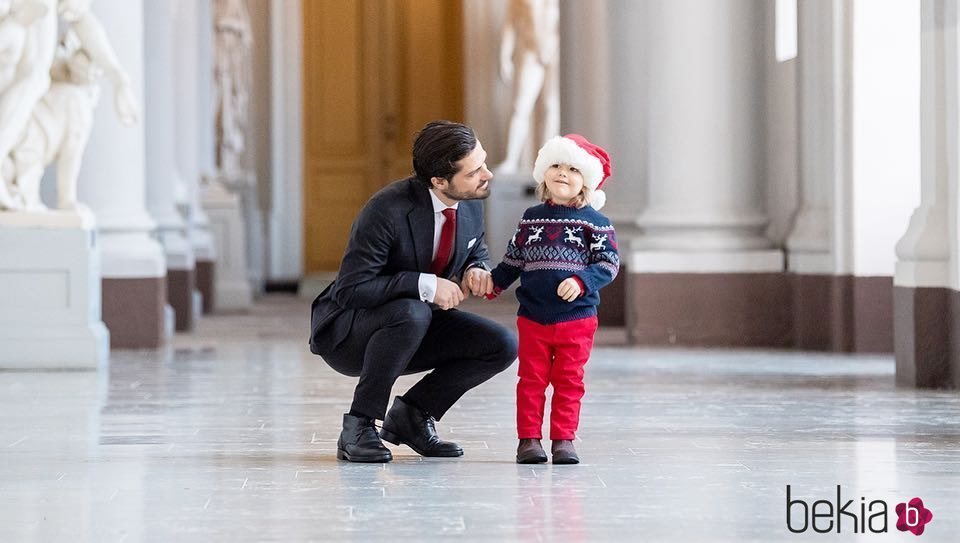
[320,298,517,420]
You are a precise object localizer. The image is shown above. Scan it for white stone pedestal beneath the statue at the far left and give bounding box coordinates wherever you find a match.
[0,208,110,369]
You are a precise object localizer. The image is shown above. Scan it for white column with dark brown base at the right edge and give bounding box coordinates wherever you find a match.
[894,0,960,388]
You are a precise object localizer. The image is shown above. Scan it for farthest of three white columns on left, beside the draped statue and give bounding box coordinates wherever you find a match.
[176,0,217,313]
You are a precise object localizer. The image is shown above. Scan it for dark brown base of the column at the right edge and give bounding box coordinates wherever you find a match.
[893,286,960,388]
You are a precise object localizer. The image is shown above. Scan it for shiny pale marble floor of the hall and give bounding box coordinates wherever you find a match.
[0,295,960,543]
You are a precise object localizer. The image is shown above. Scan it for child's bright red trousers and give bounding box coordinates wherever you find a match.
[517,317,597,440]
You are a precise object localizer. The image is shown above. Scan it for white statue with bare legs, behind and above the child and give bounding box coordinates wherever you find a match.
[496,0,560,173]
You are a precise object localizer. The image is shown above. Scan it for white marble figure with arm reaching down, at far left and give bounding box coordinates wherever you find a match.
[0,0,138,211]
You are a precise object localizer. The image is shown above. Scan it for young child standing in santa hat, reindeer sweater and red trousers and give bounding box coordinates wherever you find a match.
[490,134,620,464]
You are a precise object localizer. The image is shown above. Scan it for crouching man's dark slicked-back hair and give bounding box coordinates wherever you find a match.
[413,121,477,187]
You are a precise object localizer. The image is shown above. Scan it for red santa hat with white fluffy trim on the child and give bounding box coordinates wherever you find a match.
[533,134,613,209]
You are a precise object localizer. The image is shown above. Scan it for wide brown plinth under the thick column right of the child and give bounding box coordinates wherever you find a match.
[626,272,792,347]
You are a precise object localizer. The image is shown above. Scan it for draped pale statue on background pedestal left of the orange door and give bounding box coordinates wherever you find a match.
[214,0,253,186]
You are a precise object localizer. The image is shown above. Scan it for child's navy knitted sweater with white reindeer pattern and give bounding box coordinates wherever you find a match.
[492,202,620,324]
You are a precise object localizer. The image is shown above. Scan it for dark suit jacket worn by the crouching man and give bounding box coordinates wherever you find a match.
[310,177,490,354]
